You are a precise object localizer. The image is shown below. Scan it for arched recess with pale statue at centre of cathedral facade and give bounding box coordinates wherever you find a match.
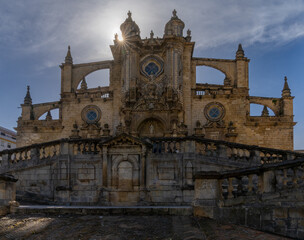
[138,118,165,137]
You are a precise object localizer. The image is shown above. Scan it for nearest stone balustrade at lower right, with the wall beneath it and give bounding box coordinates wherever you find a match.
[193,157,304,239]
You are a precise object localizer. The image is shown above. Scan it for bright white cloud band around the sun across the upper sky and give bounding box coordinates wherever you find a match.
[0,0,304,67]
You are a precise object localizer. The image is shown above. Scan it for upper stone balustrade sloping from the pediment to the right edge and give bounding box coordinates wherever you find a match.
[149,137,304,165]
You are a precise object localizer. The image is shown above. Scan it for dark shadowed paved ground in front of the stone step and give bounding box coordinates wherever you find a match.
[0,214,286,240]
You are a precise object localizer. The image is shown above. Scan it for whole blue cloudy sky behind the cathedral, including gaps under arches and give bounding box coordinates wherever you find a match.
[0,0,304,149]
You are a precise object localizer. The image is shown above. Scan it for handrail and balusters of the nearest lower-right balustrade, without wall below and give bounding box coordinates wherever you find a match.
[194,158,304,205]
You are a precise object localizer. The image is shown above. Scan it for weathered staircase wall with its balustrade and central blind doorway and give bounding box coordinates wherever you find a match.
[0,134,303,205]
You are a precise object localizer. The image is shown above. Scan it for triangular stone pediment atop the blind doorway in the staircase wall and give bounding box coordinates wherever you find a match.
[100,133,151,147]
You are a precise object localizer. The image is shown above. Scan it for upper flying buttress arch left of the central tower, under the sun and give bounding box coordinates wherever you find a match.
[72,60,113,90]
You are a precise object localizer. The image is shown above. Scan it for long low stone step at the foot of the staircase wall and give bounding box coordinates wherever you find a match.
[16,205,193,216]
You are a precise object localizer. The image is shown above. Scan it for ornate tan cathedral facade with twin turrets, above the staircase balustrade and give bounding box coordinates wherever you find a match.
[16,11,295,150]
